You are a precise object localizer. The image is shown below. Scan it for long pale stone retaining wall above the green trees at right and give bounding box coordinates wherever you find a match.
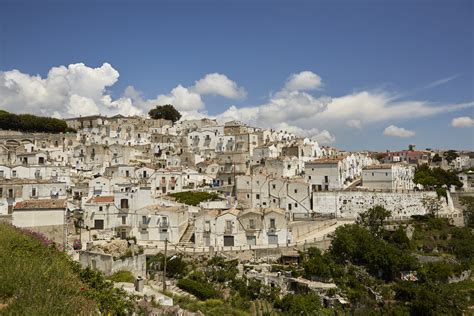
[313,191,437,219]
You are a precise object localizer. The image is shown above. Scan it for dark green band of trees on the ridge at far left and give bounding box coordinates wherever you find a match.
[0,110,72,133]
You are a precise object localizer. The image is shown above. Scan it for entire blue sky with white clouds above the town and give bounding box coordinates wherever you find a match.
[0,0,474,150]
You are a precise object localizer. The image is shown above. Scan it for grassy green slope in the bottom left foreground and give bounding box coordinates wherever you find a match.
[0,223,134,315]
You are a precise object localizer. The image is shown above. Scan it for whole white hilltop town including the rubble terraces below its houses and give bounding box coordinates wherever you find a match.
[0,110,474,314]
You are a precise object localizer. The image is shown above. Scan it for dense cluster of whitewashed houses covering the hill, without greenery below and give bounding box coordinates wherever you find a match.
[0,115,473,247]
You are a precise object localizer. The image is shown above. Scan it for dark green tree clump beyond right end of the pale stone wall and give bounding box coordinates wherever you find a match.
[413,164,463,188]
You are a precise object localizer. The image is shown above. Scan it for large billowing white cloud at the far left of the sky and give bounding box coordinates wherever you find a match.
[0,63,141,117]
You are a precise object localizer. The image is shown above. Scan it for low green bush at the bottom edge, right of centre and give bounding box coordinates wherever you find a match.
[277,293,321,315]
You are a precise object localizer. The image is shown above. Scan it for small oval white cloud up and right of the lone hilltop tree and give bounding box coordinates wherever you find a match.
[194,73,247,99]
